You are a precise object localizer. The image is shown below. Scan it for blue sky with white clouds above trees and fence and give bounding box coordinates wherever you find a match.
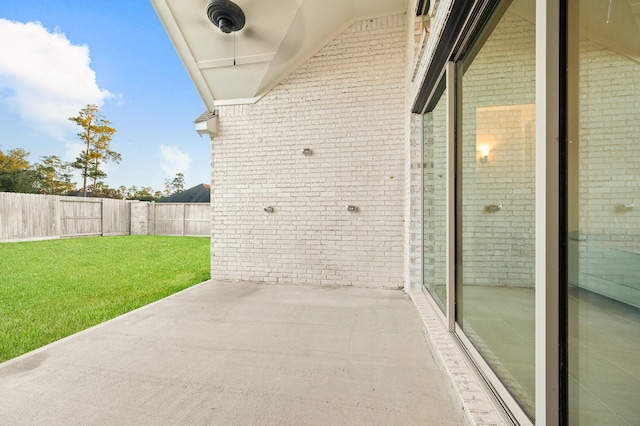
[0,0,209,190]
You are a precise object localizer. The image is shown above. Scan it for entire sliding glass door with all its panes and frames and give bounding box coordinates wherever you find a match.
[420,0,640,425]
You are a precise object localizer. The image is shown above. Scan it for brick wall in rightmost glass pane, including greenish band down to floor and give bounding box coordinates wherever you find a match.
[569,35,640,307]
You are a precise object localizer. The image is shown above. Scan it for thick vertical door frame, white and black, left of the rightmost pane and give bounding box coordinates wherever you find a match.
[535,0,568,426]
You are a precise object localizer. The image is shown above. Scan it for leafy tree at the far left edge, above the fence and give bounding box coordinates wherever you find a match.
[0,148,39,193]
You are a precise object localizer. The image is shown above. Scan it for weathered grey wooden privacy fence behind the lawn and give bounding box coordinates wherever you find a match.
[0,192,210,241]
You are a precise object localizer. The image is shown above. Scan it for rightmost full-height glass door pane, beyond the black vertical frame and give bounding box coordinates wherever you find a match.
[567,0,640,425]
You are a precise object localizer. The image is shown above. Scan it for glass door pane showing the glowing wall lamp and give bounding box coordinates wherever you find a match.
[456,0,535,418]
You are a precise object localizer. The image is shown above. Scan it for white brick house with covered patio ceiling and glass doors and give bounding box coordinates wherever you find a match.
[151,0,640,425]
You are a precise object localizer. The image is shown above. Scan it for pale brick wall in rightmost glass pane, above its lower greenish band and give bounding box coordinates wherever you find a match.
[579,40,640,246]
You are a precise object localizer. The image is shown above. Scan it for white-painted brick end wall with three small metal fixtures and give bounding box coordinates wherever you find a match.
[211,15,406,288]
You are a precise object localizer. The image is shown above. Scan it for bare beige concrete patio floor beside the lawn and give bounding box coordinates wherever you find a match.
[0,281,467,425]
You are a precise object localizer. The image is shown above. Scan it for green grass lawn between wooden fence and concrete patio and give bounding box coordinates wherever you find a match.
[0,236,210,362]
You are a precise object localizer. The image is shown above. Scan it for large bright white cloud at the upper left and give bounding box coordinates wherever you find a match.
[0,18,112,139]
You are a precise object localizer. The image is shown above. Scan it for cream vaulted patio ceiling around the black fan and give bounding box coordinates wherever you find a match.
[151,0,407,111]
